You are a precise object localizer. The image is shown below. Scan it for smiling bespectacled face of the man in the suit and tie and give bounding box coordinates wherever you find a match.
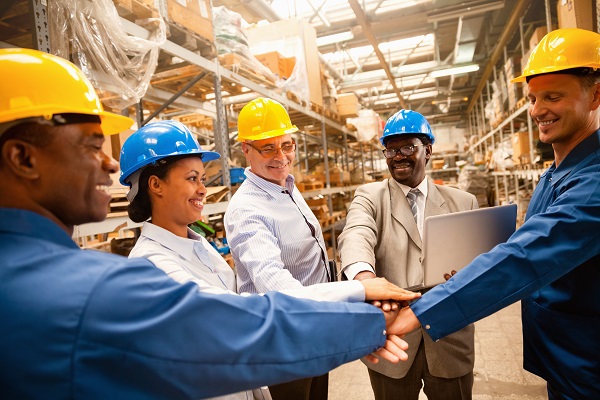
[385,135,431,188]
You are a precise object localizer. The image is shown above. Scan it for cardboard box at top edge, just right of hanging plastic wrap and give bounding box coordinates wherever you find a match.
[160,0,214,42]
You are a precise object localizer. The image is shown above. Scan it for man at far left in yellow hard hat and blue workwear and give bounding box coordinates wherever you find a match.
[0,49,418,399]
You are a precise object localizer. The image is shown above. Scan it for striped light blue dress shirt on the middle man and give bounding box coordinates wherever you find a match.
[225,168,328,293]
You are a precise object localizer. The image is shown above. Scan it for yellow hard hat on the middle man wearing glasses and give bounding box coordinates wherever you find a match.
[237,97,298,142]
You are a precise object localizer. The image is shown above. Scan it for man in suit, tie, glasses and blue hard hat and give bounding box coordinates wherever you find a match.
[339,110,477,400]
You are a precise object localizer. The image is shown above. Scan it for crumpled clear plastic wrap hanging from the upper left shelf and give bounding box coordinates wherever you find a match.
[48,0,166,110]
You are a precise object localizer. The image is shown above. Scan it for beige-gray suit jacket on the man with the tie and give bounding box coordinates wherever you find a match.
[339,179,478,378]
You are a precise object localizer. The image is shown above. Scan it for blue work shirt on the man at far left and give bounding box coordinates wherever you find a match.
[0,208,385,400]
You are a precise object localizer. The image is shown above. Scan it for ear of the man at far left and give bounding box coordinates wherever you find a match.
[1,139,40,180]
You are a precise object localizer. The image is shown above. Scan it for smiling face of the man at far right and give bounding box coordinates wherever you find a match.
[527,74,600,161]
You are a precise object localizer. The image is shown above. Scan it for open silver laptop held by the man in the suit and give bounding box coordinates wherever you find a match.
[422,204,517,288]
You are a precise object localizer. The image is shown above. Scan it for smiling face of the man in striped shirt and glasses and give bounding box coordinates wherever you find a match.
[242,134,296,186]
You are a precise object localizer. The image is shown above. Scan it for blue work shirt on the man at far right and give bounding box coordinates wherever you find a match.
[411,130,600,399]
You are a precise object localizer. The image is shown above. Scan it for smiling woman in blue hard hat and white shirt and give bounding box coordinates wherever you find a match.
[119,121,418,400]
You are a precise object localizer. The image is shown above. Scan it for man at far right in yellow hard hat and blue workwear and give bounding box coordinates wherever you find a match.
[394,28,600,400]
